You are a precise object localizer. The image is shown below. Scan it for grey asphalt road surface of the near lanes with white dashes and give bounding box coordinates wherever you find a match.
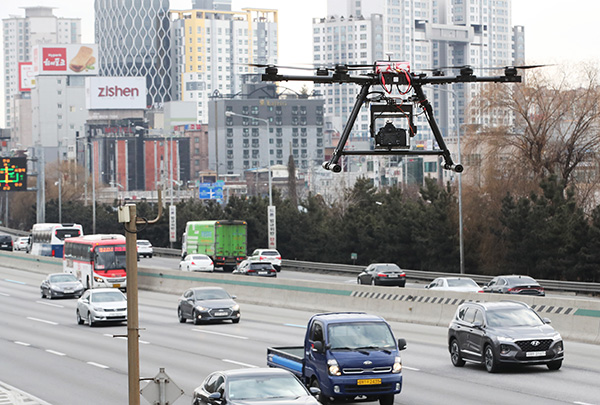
[0,266,600,405]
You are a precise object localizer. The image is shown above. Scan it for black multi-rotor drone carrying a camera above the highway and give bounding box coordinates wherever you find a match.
[252,60,542,173]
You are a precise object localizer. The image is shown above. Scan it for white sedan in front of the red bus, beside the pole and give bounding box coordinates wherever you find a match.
[75,288,127,326]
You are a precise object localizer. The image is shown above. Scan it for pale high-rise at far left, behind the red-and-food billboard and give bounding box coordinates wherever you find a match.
[2,6,81,128]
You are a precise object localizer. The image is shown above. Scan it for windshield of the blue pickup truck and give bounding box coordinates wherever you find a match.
[327,322,396,350]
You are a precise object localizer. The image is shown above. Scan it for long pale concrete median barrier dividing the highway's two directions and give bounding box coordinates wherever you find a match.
[0,252,600,344]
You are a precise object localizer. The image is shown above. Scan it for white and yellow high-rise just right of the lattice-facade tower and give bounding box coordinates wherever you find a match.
[171,5,278,123]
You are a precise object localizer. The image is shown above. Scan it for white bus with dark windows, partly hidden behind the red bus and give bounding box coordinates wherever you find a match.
[30,224,83,257]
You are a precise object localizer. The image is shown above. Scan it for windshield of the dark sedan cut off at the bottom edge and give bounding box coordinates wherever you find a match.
[227,376,307,401]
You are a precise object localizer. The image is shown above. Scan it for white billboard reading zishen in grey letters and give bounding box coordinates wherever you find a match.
[85,77,146,110]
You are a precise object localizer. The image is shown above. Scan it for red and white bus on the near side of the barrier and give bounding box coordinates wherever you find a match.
[63,234,127,290]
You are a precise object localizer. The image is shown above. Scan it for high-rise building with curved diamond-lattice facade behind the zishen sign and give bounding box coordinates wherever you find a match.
[94,0,171,106]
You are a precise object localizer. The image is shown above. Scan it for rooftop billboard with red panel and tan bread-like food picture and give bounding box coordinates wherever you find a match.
[33,44,98,76]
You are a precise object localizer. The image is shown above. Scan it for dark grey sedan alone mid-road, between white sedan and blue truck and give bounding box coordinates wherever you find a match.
[177,287,241,325]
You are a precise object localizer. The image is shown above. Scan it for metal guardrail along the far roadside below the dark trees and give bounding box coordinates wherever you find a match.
[154,247,600,295]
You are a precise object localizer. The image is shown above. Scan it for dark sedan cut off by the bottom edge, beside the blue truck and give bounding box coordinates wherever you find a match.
[192,368,319,405]
